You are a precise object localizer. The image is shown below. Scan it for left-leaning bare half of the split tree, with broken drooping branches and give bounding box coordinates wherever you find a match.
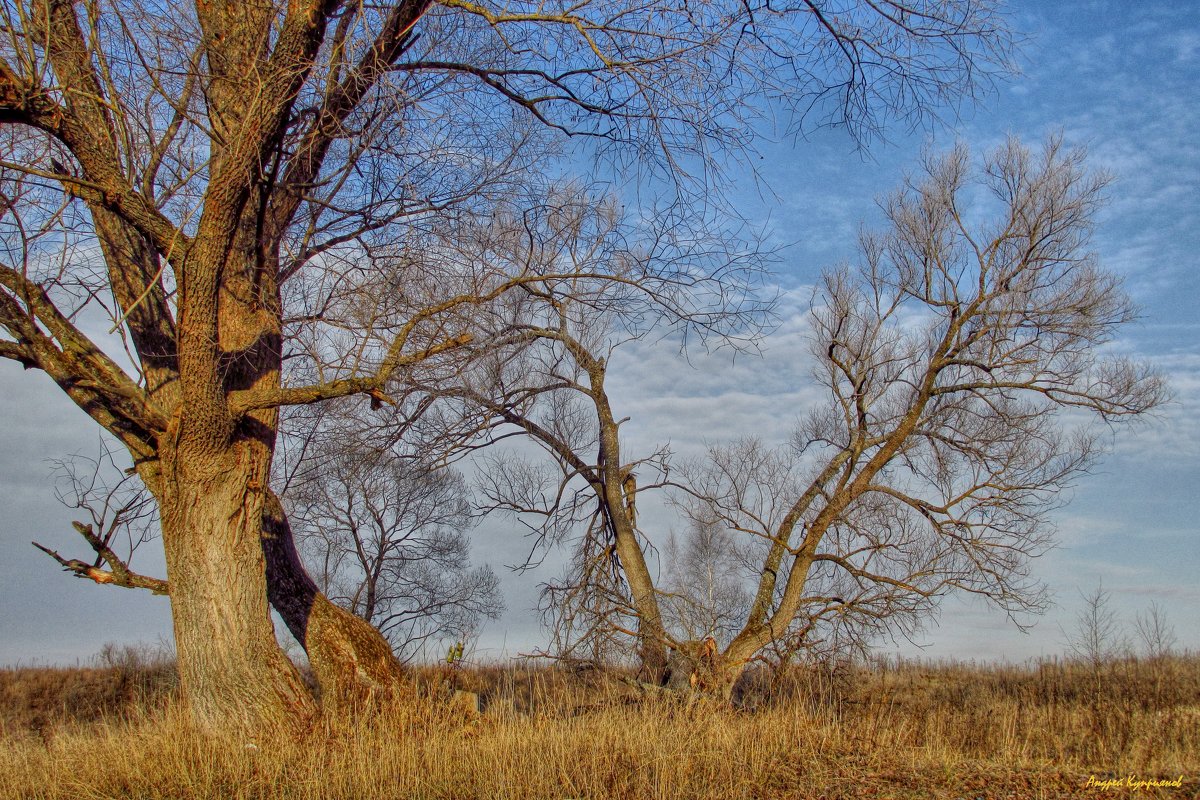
[439,187,770,675]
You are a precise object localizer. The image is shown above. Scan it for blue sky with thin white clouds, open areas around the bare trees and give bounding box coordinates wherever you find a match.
[0,1,1200,664]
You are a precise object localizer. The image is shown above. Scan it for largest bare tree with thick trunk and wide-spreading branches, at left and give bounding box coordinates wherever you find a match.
[0,0,1010,728]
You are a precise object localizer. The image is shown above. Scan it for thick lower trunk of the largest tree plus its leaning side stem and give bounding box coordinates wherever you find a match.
[156,441,407,730]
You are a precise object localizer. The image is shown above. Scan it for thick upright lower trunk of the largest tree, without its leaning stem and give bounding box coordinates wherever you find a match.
[160,443,317,732]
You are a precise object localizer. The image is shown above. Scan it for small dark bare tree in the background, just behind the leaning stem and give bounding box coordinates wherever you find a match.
[284,427,504,661]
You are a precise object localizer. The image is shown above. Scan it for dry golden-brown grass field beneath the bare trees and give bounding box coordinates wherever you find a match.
[0,652,1200,800]
